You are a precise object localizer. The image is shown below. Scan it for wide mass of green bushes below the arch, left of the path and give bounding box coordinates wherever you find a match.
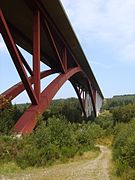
[0,117,103,168]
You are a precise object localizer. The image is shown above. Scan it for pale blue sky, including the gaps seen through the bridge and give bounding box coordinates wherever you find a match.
[0,0,135,103]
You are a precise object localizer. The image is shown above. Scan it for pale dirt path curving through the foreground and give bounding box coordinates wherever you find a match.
[0,145,111,180]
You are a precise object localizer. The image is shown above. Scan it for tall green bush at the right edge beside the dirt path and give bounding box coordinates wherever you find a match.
[113,119,135,175]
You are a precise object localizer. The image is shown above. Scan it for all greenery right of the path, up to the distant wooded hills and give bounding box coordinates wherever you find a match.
[100,95,135,180]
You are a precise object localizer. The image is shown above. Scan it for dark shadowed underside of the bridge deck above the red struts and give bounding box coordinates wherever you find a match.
[0,0,102,96]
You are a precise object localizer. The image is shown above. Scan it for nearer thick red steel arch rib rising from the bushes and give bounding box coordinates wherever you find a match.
[14,67,81,134]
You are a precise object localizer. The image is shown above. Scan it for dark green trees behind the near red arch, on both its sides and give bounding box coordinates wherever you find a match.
[0,98,83,134]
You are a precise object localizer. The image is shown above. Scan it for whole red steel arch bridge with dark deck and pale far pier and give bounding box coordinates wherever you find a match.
[0,0,103,134]
